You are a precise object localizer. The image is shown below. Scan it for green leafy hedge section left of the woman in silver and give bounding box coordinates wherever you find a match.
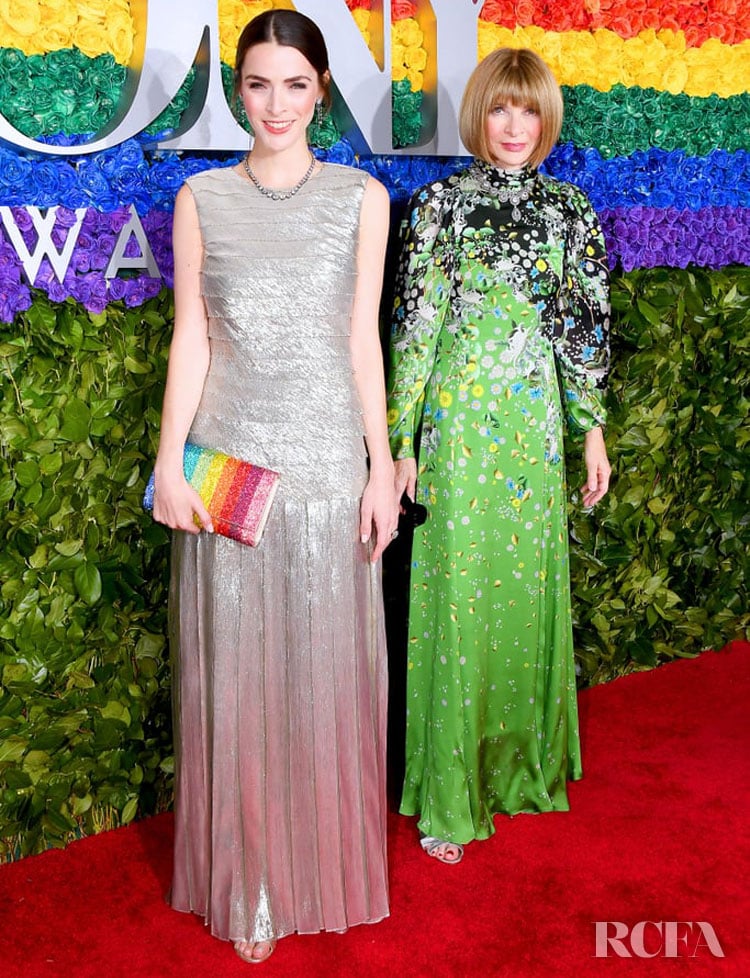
[0,290,172,858]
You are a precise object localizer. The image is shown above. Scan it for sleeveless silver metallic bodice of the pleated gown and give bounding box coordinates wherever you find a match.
[188,164,367,499]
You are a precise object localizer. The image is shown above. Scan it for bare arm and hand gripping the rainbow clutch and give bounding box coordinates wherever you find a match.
[154,187,213,533]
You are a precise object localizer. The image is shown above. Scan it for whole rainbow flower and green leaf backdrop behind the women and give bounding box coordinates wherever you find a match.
[0,0,750,861]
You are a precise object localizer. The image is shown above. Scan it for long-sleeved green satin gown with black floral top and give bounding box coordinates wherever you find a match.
[389,161,609,843]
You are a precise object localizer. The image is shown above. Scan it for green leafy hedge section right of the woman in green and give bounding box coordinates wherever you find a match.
[570,267,750,682]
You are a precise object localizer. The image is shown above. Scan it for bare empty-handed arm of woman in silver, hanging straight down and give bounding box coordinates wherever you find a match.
[350,179,398,563]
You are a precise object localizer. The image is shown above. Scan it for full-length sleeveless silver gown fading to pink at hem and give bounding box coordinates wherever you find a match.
[170,164,388,940]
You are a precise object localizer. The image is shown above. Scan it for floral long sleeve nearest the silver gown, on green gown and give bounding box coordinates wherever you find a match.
[388,183,453,459]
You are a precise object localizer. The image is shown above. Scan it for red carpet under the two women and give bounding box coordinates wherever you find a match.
[0,643,750,978]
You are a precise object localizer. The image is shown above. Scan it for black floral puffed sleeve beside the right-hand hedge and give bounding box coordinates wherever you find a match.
[554,188,610,431]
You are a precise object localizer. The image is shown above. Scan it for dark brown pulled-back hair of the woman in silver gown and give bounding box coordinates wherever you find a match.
[234,9,331,109]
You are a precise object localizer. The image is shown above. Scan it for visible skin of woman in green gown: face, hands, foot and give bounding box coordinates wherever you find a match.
[394,102,611,864]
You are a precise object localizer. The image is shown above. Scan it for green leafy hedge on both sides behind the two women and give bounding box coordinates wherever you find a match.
[0,267,750,859]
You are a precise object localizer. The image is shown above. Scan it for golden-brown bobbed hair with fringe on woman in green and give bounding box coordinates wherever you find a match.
[458,48,563,167]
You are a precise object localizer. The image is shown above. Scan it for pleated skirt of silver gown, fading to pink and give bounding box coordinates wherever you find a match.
[170,499,388,941]
